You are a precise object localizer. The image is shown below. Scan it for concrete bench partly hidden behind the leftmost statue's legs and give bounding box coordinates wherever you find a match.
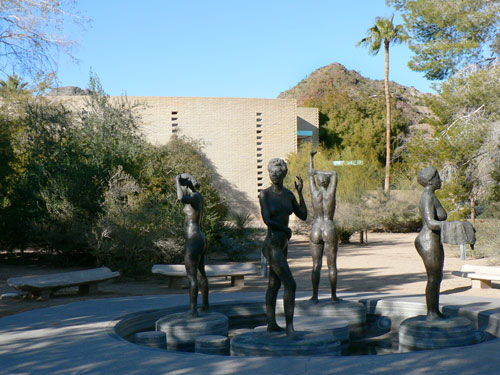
[151,263,257,288]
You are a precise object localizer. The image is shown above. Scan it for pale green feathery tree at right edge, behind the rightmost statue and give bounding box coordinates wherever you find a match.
[405,65,500,219]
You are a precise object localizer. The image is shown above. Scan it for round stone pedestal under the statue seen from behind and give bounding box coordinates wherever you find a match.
[294,300,366,337]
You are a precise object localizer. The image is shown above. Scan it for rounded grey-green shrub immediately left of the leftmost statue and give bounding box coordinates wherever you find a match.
[92,167,183,275]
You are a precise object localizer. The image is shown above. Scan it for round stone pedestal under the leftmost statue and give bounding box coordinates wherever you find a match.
[156,312,228,352]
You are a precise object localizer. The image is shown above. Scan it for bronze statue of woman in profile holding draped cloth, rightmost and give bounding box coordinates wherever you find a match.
[415,167,447,320]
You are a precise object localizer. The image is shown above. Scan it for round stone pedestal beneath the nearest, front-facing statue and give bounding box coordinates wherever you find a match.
[231,331,341,357]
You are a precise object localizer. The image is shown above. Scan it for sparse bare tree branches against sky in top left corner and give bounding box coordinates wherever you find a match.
[0,0,87,79]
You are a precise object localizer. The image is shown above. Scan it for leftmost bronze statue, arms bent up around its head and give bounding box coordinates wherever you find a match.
[176,173,209,317]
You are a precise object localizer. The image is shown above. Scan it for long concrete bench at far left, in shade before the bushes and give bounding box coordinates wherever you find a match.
[7,267,120,298]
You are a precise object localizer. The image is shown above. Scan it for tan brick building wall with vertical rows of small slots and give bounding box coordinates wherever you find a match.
[54,96,310,212]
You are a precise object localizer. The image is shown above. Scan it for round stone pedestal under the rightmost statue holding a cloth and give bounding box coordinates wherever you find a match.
[399,315,477,352]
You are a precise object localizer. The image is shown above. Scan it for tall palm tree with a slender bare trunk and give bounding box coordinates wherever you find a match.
[356,16,408,193]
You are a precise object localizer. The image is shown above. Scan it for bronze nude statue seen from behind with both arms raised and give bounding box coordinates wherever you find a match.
[309,151,340,303]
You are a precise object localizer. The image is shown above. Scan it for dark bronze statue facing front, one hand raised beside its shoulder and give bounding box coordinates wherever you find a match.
[259,158,307,336]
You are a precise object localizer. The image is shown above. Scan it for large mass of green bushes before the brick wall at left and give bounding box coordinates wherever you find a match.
[0,76,226,275]
